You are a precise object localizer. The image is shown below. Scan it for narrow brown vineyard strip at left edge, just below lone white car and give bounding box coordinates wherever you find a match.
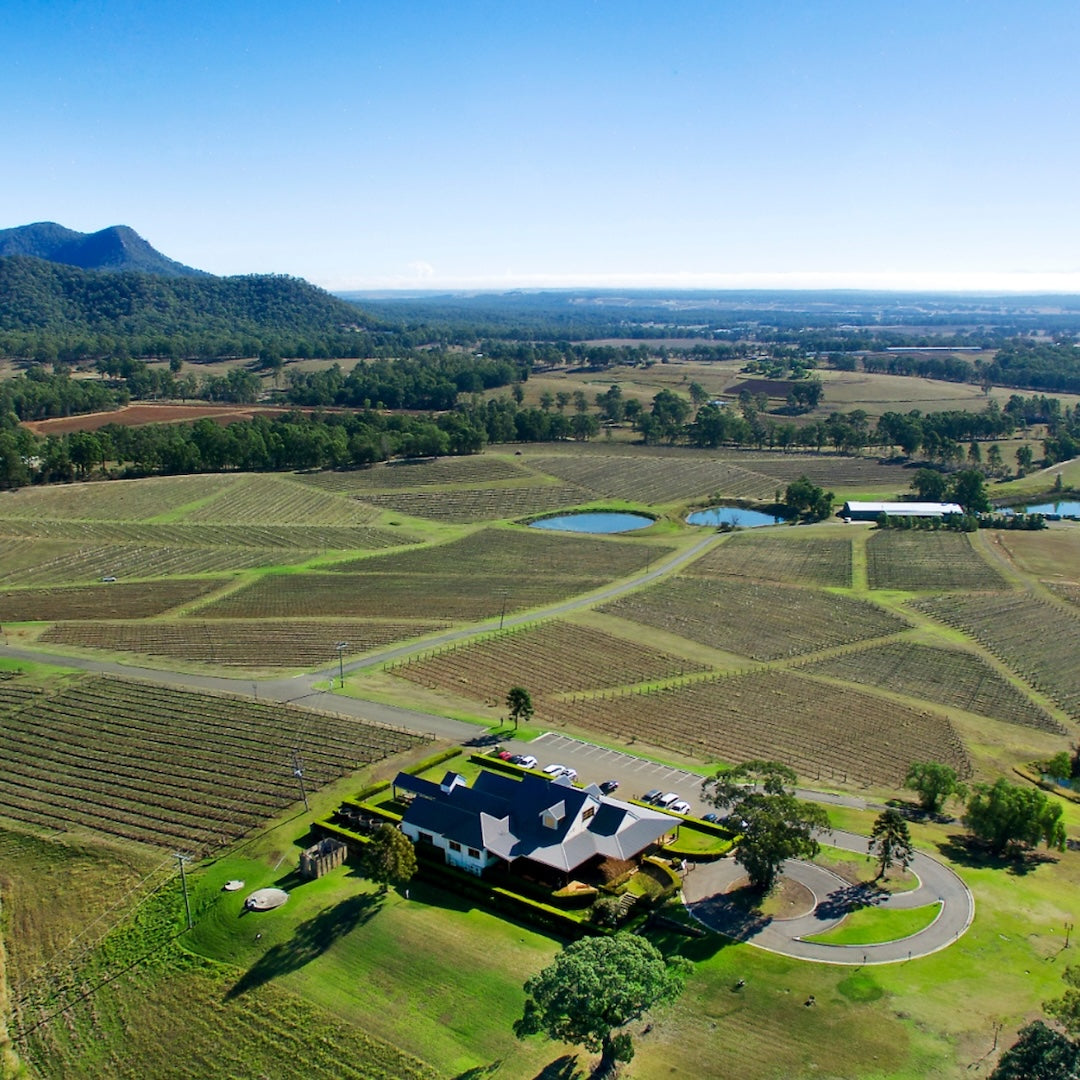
[0,578,222,622]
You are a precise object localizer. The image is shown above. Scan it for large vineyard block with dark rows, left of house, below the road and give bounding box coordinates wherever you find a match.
[0,677,423,852]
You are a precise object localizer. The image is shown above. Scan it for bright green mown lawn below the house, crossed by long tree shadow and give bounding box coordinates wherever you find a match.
[183,859,566,1076]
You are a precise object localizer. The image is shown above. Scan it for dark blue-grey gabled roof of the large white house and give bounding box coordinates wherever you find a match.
[394,770,675,872]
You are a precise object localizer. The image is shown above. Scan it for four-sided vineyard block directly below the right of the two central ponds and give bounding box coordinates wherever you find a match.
[685,529,851,589]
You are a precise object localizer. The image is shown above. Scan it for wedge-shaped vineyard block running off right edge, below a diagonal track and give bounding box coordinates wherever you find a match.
[912,592,1080,720]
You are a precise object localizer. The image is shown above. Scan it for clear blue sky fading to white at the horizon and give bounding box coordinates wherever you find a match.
[0,0,1080,291]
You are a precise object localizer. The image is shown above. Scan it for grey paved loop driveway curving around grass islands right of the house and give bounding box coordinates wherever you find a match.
[683,832,975,964]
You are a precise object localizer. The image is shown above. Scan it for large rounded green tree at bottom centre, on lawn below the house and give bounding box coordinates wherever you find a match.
[514,933,690,1076]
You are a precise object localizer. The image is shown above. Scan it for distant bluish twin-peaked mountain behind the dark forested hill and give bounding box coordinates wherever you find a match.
[0,221,208,278]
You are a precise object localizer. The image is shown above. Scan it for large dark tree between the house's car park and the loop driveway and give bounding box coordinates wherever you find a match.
[704,761,828,892]
